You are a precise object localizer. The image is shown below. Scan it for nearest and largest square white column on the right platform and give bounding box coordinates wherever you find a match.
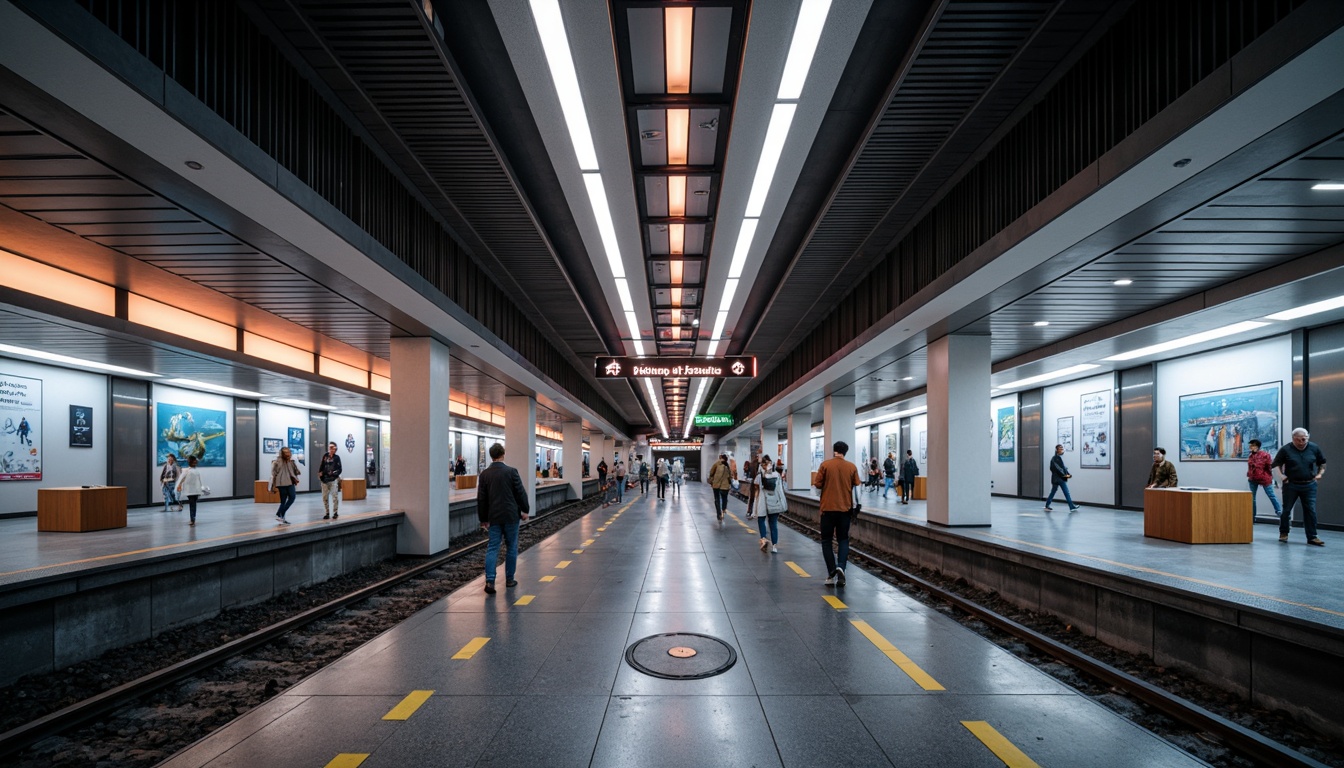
[926,336,992,526]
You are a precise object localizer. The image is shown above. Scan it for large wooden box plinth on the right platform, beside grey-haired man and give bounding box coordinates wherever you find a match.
[1144,488,1254,543]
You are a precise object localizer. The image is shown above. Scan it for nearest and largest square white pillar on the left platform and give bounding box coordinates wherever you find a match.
[391,338,453,554]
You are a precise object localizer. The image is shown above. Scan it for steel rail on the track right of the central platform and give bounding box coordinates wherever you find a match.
[781,515,1328,768]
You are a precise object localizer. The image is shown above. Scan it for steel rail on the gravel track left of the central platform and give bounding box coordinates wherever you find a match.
[0,496,591,757]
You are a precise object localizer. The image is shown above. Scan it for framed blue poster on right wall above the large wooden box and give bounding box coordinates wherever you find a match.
[1179,382,1284,461]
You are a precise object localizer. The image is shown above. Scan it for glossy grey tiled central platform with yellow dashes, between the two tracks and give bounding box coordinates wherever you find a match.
[164,484,1202,768]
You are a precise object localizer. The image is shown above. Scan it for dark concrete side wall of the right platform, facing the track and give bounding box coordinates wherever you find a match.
[789,495,1344,738]
